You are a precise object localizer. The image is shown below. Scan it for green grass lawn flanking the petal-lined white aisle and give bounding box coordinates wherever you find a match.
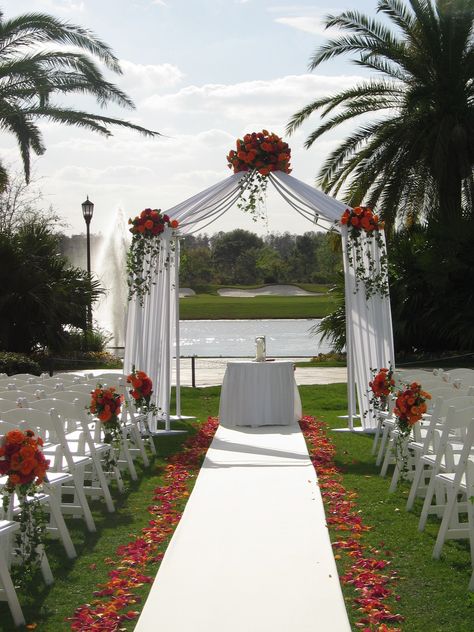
[0,384,474,632]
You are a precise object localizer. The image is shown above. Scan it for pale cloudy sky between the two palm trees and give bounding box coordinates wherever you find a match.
[0,0,376,235]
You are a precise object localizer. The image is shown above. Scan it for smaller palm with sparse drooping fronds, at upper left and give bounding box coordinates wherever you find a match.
[0,11,157,190]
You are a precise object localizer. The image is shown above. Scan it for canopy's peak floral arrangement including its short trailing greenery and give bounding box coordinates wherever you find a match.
[227,129,291,220]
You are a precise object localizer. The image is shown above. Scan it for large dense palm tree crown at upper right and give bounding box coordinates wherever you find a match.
[288,0,474,231]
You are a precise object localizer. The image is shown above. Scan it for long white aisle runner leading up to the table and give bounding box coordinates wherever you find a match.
[135,425,351,632]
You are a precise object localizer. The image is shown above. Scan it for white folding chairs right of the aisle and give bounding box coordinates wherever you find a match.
[374,369,474,590]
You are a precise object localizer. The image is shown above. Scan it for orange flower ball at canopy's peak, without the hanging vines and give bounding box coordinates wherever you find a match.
[227,129,291,176]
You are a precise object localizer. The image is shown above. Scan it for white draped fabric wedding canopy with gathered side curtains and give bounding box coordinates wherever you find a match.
[124,171,394,429]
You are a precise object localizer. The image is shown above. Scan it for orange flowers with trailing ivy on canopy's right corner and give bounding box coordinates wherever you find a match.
[340,206,388,299]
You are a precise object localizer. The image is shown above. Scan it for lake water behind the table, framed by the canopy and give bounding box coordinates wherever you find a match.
[174,319,330,358]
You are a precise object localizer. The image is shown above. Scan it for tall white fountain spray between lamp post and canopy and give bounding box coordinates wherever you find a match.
[94,209,129,347]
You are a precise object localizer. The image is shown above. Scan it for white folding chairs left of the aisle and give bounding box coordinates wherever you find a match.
[0,373,156,625]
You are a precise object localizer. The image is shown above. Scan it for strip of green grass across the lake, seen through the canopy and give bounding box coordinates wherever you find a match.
[179,294,336,320]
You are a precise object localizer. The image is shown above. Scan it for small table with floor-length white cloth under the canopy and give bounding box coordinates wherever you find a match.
[219,361,301,426]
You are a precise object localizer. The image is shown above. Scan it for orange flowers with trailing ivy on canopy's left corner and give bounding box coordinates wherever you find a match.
[127,208,179,305]
